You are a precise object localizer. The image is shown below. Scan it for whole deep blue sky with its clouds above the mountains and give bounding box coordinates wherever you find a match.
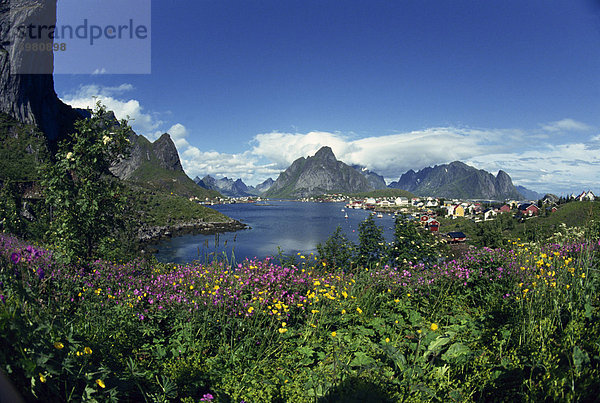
[55,0,600,194]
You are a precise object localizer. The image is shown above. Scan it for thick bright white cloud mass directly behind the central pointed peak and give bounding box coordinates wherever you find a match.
[252,128,520,180]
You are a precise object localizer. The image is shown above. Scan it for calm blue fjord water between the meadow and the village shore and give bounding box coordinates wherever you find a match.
[153,201,394,263]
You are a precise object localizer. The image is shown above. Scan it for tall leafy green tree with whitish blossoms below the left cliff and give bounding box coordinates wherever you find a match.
[41,102,131,258]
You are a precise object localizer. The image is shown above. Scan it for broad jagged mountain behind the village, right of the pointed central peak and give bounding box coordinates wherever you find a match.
[389,161,521,200]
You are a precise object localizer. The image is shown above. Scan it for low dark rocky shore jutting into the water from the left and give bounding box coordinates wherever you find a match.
[137,220,250,243]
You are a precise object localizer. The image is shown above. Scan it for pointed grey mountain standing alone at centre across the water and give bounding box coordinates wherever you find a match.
[264,147,373,198]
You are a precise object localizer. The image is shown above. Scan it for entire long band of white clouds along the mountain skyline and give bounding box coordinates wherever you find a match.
[62,84,600,194]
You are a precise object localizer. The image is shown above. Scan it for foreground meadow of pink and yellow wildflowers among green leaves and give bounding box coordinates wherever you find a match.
[0,219,600,402]
